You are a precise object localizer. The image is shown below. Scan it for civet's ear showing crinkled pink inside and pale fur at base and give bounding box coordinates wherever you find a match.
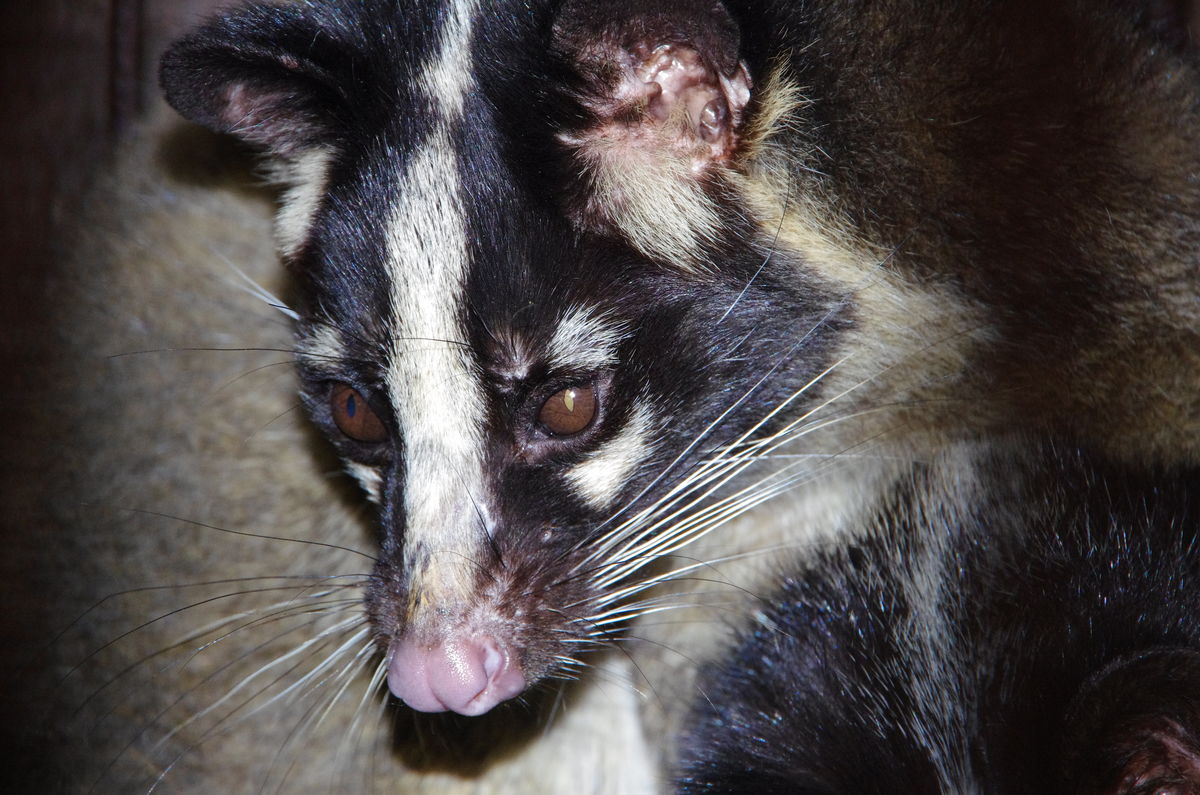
[553,0,750,259]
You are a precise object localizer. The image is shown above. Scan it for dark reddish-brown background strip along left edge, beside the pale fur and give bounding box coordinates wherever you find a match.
[0,0,229,791]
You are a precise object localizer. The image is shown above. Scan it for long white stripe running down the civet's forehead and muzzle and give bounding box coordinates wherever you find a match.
[388,2,485,604]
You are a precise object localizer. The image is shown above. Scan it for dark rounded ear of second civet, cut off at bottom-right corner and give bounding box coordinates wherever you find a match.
[1060,648,1200,795]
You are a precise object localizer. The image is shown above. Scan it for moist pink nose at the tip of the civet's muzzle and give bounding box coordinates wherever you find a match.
[388,635,524,715]
